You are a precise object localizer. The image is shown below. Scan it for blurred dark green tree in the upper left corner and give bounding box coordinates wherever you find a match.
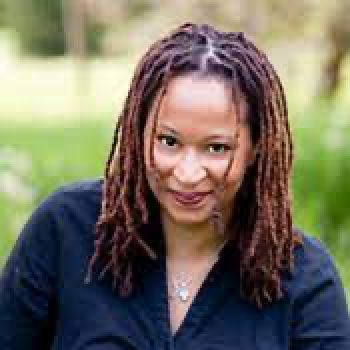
[1,0,102,56]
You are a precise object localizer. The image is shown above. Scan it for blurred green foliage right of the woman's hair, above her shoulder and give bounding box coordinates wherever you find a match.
[293,101,350,251]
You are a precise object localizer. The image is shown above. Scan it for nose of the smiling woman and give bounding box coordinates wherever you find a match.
[173,150,207,186]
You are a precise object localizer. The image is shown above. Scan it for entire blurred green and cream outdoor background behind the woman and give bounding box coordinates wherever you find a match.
[0,0,350,300]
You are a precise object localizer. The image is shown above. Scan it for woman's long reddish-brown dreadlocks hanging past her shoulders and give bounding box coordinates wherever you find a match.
[86,23,301,307]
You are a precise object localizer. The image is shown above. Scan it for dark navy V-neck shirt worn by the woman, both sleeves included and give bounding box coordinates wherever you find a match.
[0,180,350,350]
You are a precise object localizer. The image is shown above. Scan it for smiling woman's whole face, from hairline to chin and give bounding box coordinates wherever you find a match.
[144,74,255,224]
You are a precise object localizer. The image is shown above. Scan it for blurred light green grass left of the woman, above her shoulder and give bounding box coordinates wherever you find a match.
[0,120,113,266]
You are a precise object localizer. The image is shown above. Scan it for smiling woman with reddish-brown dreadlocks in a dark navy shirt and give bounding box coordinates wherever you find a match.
[0,24,350,350]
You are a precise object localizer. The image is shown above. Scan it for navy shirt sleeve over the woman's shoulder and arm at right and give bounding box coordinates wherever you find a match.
[289,233,350,344]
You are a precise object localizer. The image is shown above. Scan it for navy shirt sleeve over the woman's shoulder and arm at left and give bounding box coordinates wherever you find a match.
[0,180,102,336]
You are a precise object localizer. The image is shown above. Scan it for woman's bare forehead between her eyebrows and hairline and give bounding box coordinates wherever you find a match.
[152,74,244,132]
